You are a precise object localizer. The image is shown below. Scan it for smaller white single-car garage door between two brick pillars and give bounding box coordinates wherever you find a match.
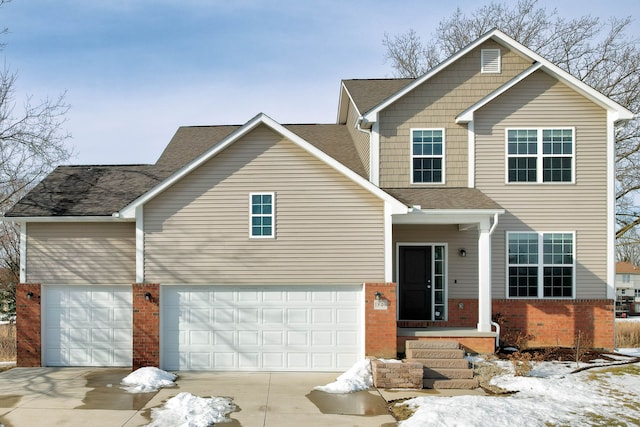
[42,286,133,366]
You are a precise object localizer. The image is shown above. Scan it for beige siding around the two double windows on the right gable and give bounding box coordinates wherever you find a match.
[476,71,607,298]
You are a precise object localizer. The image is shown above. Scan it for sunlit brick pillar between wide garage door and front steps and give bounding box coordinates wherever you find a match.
[364,283,397,358]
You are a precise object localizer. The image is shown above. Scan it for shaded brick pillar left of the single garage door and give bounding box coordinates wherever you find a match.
[16,283,42,368]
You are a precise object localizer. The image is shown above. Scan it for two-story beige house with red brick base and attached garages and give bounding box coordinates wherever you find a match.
[7,30,633,371]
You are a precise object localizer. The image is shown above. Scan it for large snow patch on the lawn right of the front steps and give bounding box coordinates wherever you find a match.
[398,361,640,427]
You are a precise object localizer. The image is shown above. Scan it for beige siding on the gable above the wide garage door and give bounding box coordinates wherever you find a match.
[144,126,384,284]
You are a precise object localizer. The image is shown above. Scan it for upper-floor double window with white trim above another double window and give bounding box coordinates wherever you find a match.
[506,128,575,183]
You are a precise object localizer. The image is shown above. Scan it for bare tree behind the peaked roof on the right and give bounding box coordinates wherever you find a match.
[382,0,640,238]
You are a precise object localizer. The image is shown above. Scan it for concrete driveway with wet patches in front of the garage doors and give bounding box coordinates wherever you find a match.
[0,368,398,427]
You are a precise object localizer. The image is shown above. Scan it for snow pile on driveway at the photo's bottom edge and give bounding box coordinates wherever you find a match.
[147,392,236,427]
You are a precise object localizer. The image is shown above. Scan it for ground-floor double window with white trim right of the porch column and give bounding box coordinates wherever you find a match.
[507,232,575,298]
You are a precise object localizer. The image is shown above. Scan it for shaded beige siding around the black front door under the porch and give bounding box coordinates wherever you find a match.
[393,225,478,298]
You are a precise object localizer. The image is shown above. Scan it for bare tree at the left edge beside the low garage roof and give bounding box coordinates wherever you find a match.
[0,0,72,320]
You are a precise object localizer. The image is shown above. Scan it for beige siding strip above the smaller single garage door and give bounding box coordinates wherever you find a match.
[27,222,136,285]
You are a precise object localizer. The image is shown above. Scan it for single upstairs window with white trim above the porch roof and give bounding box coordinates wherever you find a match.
[411,129,444,184]
